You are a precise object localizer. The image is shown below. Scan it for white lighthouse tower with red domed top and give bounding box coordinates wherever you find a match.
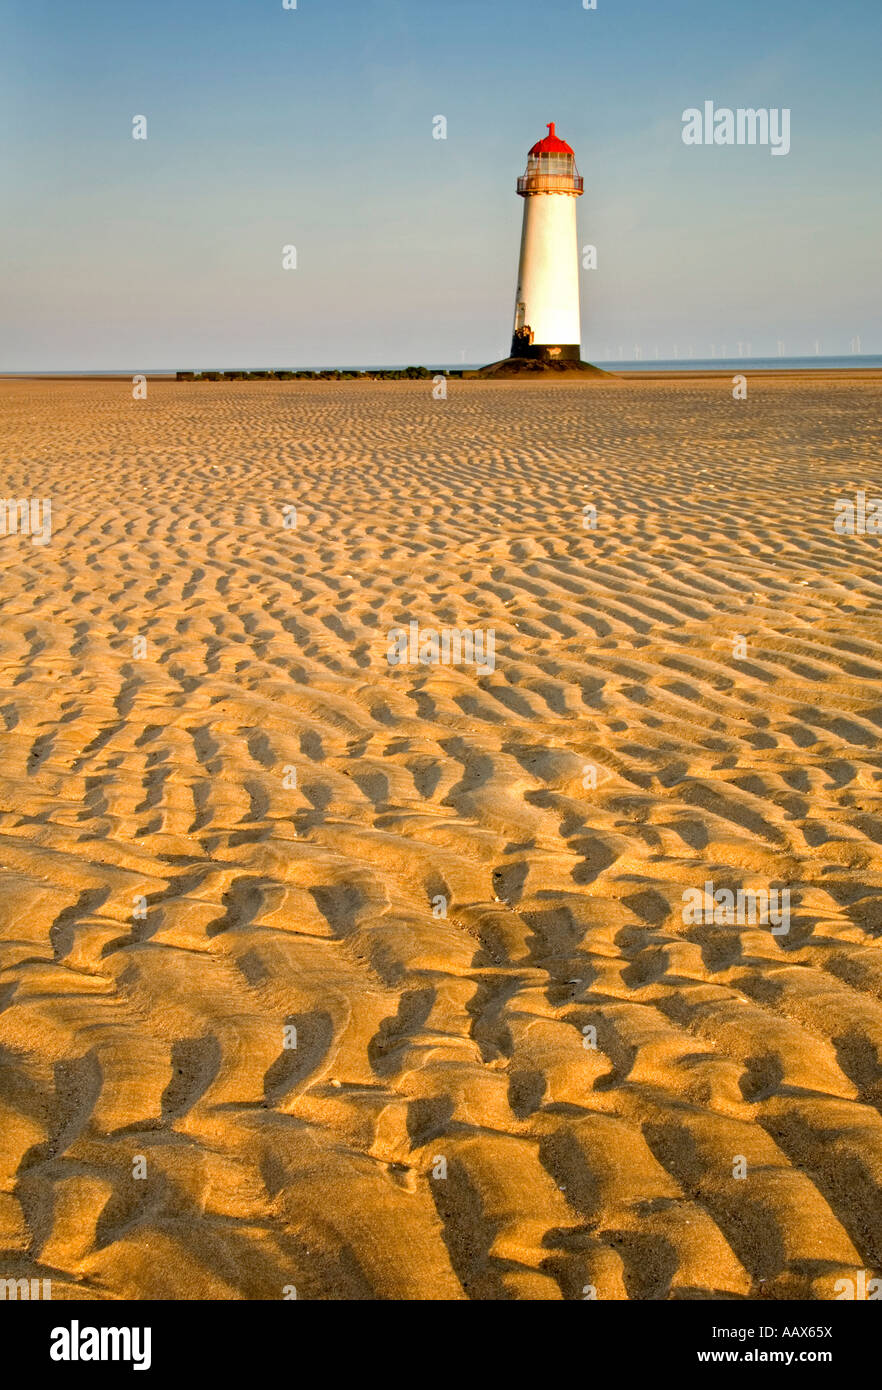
[511,121,583,361]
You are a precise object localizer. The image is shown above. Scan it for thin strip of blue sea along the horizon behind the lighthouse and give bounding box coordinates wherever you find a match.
[0,353,882,377]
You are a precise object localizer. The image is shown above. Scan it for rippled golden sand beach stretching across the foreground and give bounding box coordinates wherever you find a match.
[0,374,882,1300]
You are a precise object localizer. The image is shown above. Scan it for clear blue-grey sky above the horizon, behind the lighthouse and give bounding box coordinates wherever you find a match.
[0,0,882,371]
